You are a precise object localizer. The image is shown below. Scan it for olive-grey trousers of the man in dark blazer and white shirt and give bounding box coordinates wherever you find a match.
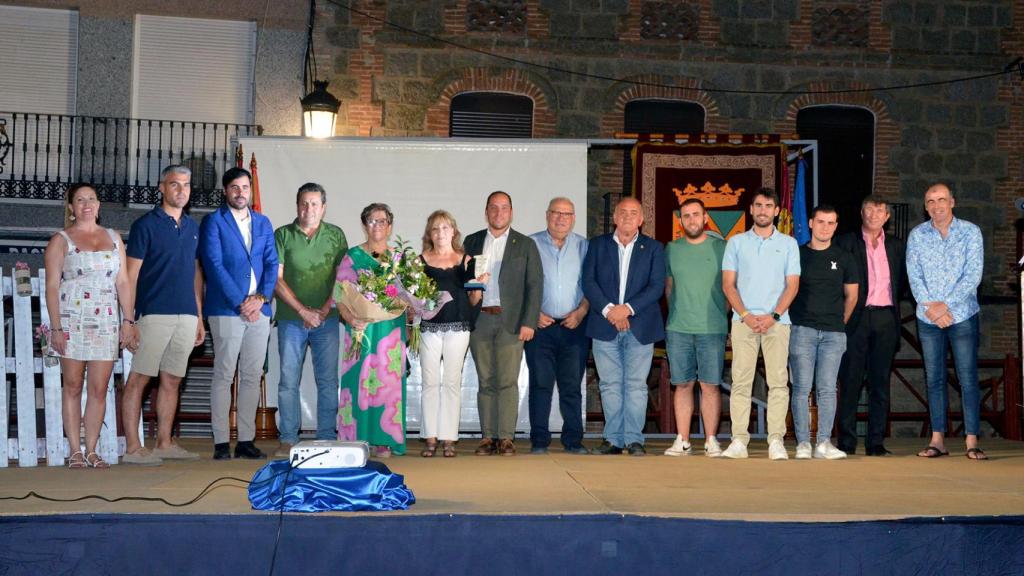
[469,314,522,439]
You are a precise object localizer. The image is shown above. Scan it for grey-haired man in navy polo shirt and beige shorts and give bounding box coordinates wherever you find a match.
[122,165,206,466]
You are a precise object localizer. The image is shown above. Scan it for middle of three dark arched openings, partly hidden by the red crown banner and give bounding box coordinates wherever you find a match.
[623,99,705,196]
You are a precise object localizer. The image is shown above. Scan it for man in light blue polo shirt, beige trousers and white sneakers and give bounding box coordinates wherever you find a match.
[722,188,800,460]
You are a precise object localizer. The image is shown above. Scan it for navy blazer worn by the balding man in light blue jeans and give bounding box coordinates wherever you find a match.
[583,233,665,344]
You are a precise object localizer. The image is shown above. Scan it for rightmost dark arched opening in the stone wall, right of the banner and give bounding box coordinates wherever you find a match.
[797,106,874,234]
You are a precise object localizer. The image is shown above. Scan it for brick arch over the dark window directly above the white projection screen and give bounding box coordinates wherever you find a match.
[427,68,557,138]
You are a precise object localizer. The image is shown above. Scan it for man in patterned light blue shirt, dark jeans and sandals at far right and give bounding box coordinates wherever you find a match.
[906,183,986,460]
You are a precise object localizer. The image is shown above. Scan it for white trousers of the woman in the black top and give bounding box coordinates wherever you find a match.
[420,331,469,441]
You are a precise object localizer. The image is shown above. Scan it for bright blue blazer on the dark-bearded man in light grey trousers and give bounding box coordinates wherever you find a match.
[199,205,278,317]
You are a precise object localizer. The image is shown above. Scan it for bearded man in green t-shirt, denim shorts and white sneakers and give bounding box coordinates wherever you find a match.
[665,198,728,458]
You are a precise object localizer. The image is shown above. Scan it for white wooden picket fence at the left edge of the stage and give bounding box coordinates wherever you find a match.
[0,269,131,467]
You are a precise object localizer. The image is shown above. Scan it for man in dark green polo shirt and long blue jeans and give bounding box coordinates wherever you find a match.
[273,182,348,458]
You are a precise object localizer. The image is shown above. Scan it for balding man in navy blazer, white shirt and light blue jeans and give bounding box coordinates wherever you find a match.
[583,198,665,456]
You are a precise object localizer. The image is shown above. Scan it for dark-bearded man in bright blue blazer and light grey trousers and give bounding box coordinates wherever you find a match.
[199,168,278,460]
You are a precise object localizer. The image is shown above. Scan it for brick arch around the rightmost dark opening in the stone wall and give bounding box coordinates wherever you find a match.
[775,82,899,200]
